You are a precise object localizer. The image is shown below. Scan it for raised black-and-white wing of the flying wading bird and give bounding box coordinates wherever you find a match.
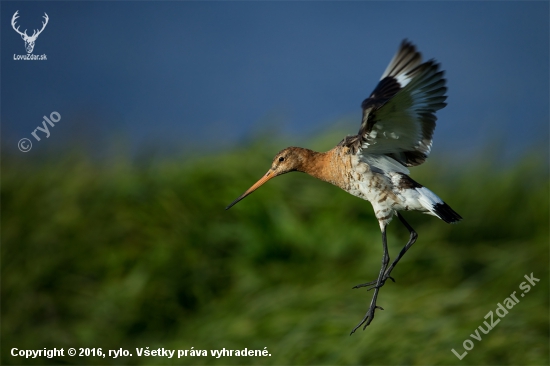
[349,40,447,166]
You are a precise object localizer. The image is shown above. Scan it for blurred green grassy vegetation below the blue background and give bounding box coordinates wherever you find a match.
[1,136,549,365]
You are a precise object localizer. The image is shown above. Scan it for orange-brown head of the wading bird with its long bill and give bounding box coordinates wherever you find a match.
[225,147,309,210]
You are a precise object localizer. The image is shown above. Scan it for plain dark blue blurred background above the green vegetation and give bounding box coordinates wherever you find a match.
[1,2,549,158]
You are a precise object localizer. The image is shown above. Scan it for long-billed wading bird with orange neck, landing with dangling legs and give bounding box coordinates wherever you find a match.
[226,39,462,335]
